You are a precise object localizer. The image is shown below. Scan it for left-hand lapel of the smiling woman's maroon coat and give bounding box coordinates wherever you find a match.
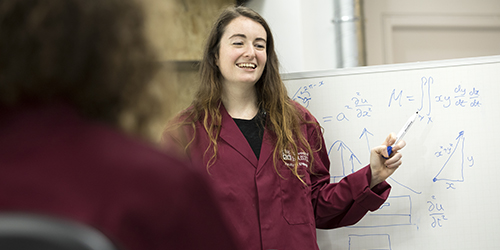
[219,104,258,168]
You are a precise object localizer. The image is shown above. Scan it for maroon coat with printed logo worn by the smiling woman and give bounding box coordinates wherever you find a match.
[163,102,390,250]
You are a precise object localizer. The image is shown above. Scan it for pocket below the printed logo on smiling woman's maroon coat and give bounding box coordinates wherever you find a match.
[280,166,314,225]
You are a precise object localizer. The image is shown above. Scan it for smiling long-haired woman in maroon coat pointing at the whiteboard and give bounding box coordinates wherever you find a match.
[162,4,404,250]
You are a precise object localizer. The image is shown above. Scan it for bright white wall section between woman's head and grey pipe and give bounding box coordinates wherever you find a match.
[246,0,337,73]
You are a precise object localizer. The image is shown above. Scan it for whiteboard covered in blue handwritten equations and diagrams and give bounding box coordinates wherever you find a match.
[283,56,500,250]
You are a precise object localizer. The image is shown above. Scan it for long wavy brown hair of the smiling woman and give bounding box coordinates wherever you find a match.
[171,6,321,183]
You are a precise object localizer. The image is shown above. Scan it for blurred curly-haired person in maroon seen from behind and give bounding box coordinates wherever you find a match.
[0,0,237,250]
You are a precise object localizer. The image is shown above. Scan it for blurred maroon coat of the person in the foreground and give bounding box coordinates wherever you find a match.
[0,104,240,250]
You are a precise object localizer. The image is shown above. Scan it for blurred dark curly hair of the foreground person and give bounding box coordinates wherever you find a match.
[0,0,160,138]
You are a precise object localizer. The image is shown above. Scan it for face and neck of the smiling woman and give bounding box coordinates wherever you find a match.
[216,16,267,104]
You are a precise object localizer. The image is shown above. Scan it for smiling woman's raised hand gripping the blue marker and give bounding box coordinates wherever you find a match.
[370,133,406,188]
